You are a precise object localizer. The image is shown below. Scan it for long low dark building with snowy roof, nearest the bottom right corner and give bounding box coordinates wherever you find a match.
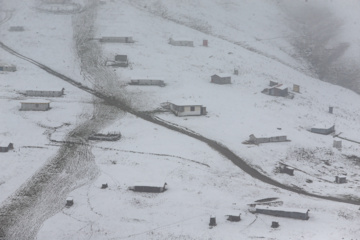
[252,206,310,220]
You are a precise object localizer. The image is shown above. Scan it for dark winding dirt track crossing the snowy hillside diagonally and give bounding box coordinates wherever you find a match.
[0,42,360,205]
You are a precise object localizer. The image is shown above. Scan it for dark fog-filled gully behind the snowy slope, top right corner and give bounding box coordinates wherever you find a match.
[281,0,360,93]
